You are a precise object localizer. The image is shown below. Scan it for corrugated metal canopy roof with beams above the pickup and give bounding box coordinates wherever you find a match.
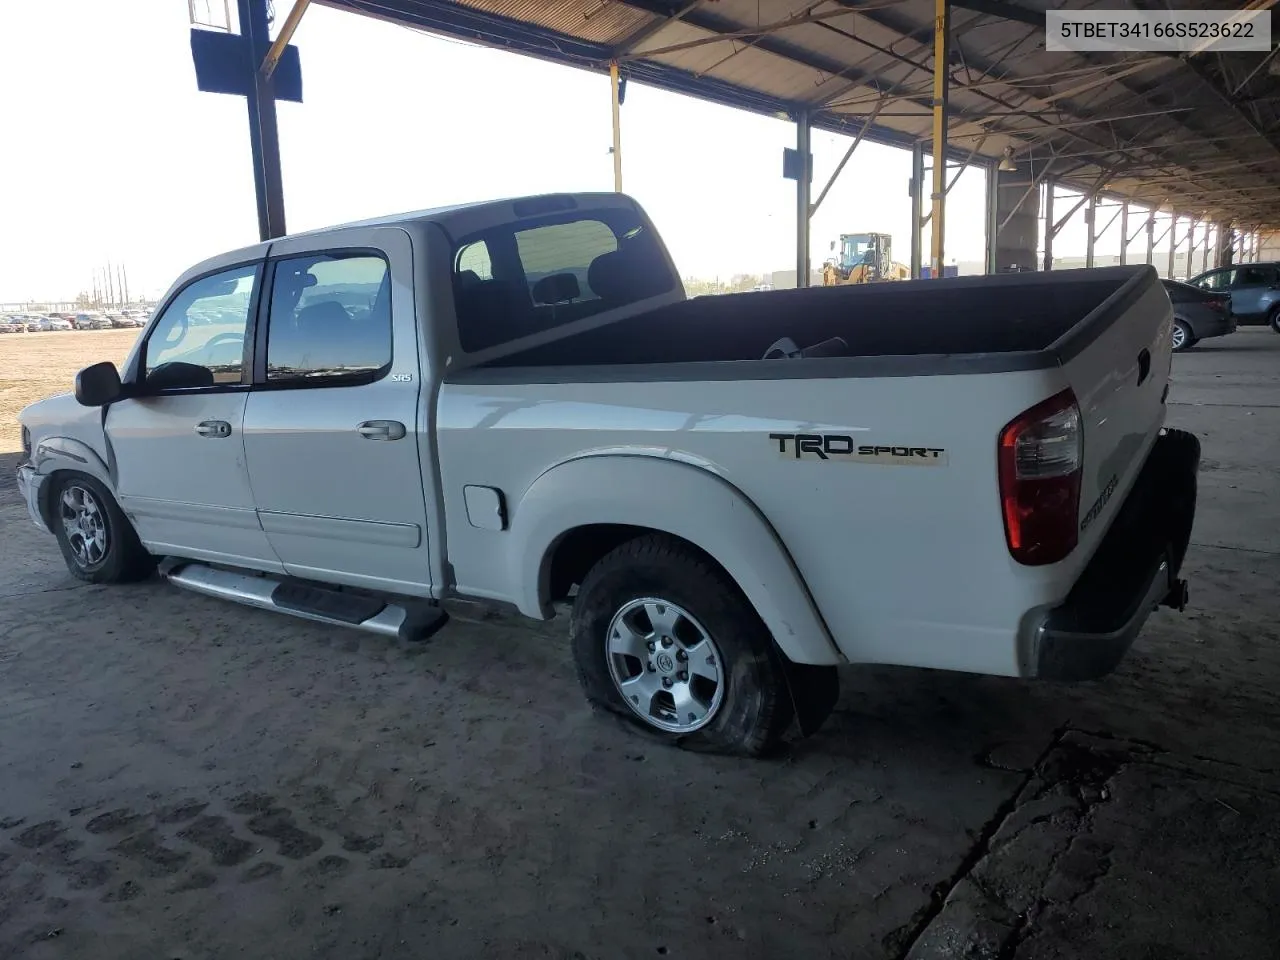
[319,0,1280,229]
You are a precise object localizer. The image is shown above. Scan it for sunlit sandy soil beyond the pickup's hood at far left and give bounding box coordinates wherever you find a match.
[0,330,142,453]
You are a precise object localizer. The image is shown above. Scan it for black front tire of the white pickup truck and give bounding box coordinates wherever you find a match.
[49,472,156,584]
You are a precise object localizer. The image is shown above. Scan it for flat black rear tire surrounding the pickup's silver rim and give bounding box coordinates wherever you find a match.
[570,534,794,756]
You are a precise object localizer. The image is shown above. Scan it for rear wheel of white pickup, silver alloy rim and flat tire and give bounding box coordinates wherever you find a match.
[570,535,794,756]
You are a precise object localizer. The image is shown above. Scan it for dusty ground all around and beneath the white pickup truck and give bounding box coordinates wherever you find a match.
[0,330,1280,960]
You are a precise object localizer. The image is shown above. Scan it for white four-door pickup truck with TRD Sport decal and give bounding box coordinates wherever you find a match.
[18,195,1199,754]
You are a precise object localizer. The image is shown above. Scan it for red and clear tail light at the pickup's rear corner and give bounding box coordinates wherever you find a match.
[998,389,1084,566]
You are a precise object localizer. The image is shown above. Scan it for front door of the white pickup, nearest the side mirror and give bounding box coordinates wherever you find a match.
[106,261,280,571]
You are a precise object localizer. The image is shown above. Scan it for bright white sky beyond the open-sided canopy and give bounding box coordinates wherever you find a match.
[0,0,1152,302]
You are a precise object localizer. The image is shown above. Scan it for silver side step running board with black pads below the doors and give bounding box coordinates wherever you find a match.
[160,559,449,640]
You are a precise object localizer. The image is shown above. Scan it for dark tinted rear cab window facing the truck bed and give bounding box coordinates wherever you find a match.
[453,207,676,353]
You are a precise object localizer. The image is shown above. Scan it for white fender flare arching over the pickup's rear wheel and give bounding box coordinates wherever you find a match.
[508,453,846,664]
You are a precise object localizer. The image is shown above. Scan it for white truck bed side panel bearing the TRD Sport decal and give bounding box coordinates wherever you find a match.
[438,361,1075,675]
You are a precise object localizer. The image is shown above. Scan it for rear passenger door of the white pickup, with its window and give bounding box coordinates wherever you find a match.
[244,228,431,595]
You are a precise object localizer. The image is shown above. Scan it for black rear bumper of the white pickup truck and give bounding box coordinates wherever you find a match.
[1024,430,1201,681]
